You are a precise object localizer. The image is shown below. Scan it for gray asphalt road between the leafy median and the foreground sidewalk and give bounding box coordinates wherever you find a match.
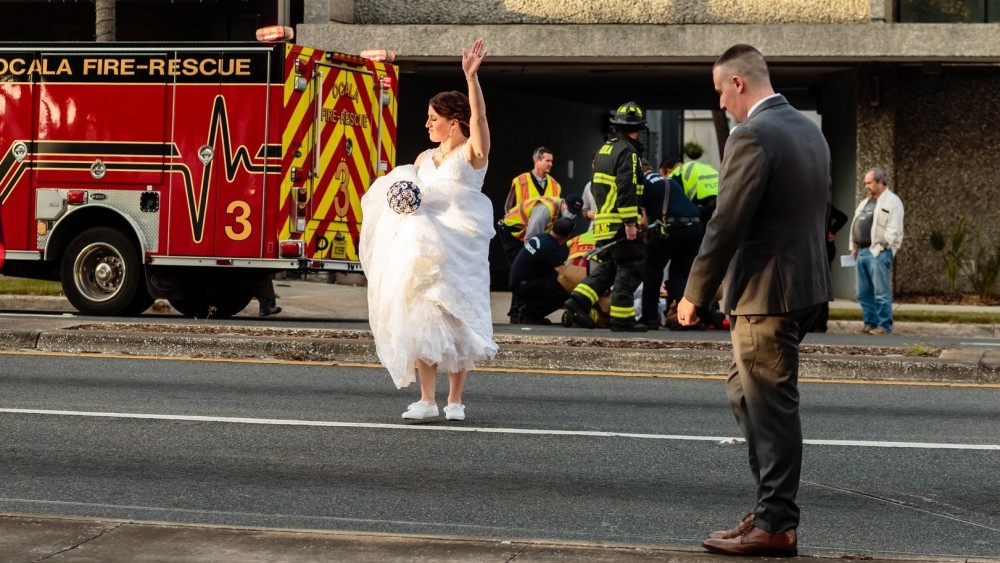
[0,353,1000,557]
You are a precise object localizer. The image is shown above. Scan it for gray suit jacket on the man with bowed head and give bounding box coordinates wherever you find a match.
[684,96,833,315]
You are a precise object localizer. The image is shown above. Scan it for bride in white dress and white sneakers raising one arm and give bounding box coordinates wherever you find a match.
[360,39,497,420]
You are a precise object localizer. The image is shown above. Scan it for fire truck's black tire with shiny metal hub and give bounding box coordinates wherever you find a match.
[59,227,146,316]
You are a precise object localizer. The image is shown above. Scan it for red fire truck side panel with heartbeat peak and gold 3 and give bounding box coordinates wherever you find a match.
[165,49,268,258]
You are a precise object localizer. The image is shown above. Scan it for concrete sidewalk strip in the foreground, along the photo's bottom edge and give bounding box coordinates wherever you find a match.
[0,515,984,563]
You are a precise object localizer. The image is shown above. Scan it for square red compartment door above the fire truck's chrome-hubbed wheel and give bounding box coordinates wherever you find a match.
[36,50,170,187]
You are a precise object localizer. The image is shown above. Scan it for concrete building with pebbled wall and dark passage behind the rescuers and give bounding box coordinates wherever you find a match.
[297,0,1000,297]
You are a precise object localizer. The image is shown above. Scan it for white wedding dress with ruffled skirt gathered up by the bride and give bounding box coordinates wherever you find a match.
[360,150,497,388]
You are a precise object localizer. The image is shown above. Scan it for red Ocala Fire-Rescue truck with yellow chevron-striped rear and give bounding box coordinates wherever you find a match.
[0,30,398,318]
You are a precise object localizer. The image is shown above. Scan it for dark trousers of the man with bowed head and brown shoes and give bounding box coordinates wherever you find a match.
[726,304,820,534]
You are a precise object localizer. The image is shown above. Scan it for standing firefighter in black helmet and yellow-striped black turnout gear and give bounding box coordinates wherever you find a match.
[564,102,646,332]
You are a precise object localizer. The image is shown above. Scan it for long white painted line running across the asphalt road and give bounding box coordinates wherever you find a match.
[0,408,1000,451]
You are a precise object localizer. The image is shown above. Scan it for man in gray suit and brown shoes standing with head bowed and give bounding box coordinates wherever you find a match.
[677,45,833,555]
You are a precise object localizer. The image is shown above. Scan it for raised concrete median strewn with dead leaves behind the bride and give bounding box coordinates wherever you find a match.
[0,327,1000,384]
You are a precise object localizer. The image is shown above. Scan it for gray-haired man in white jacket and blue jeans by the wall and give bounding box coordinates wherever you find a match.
[851,168,903,334]
